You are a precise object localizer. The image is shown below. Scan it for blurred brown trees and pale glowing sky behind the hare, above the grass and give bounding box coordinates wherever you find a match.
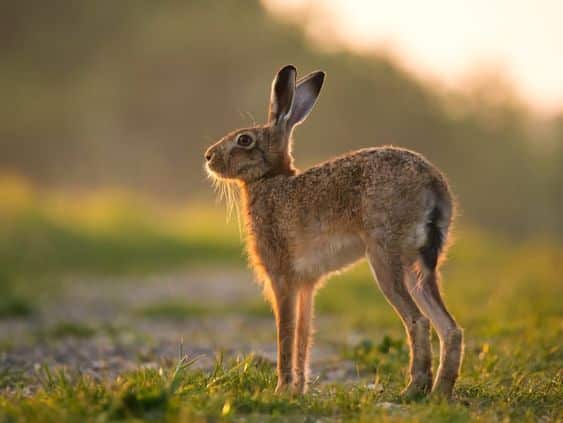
[0,0,563,239]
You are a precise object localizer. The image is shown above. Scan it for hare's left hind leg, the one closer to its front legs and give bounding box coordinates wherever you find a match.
[367,242,432,398]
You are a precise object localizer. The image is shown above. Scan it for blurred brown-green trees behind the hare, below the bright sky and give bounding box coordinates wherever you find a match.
[0,0,563,237]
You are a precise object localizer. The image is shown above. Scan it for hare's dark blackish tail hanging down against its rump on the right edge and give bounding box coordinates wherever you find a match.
[419,189,452,272]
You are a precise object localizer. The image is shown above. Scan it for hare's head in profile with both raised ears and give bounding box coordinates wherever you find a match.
[205,65,324,182]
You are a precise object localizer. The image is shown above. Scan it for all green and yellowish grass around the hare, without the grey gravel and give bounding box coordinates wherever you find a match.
[0,178,563,422]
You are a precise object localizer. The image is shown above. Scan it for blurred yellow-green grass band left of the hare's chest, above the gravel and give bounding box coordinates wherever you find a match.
[0,182,244,308]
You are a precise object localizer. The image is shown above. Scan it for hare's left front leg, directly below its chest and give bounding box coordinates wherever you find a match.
[274,287,297,392]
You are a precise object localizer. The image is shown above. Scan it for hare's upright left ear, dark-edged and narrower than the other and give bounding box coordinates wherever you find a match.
[268,65,297,125]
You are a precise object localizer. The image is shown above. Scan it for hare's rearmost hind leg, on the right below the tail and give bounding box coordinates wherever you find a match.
[407,268,463,397]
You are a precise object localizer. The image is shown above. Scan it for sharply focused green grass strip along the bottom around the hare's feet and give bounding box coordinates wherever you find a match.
[0,351,563,422]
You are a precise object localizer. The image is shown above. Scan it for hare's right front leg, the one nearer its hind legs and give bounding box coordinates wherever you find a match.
[293,284,314,394]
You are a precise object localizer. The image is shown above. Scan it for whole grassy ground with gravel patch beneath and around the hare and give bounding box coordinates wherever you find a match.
[0,192,563,422]
